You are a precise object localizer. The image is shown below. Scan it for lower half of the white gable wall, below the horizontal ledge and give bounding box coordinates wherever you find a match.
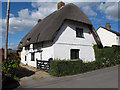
[54,44,95,62]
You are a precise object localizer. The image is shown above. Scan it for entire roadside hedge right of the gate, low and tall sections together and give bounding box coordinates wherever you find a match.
[50,45,120,76]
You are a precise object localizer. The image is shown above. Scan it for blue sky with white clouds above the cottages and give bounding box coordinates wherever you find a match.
[0,0,119,49]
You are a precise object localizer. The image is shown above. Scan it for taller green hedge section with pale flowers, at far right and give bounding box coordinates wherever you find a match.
[94,45,120,67]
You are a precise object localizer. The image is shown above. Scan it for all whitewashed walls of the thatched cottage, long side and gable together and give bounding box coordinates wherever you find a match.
[21,22,96,67]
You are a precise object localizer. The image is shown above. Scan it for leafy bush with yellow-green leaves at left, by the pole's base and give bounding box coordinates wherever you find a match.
[2,53,20,79]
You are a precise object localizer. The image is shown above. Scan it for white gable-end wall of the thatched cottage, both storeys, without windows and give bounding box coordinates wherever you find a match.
[54,22,96,62]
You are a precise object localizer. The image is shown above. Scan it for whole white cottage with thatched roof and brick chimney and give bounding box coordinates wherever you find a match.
[18,2,102,67]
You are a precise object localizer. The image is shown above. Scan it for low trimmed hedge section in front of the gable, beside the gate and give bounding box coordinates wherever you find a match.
[50,60,104,76]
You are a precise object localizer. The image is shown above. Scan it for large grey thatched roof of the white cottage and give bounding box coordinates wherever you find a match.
[18,3,101,48]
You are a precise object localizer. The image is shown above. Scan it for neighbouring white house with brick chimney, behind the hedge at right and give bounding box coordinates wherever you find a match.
[97,23,120,47]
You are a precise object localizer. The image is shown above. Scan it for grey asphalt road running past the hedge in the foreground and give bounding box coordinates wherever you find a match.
[19,66,118,88]
